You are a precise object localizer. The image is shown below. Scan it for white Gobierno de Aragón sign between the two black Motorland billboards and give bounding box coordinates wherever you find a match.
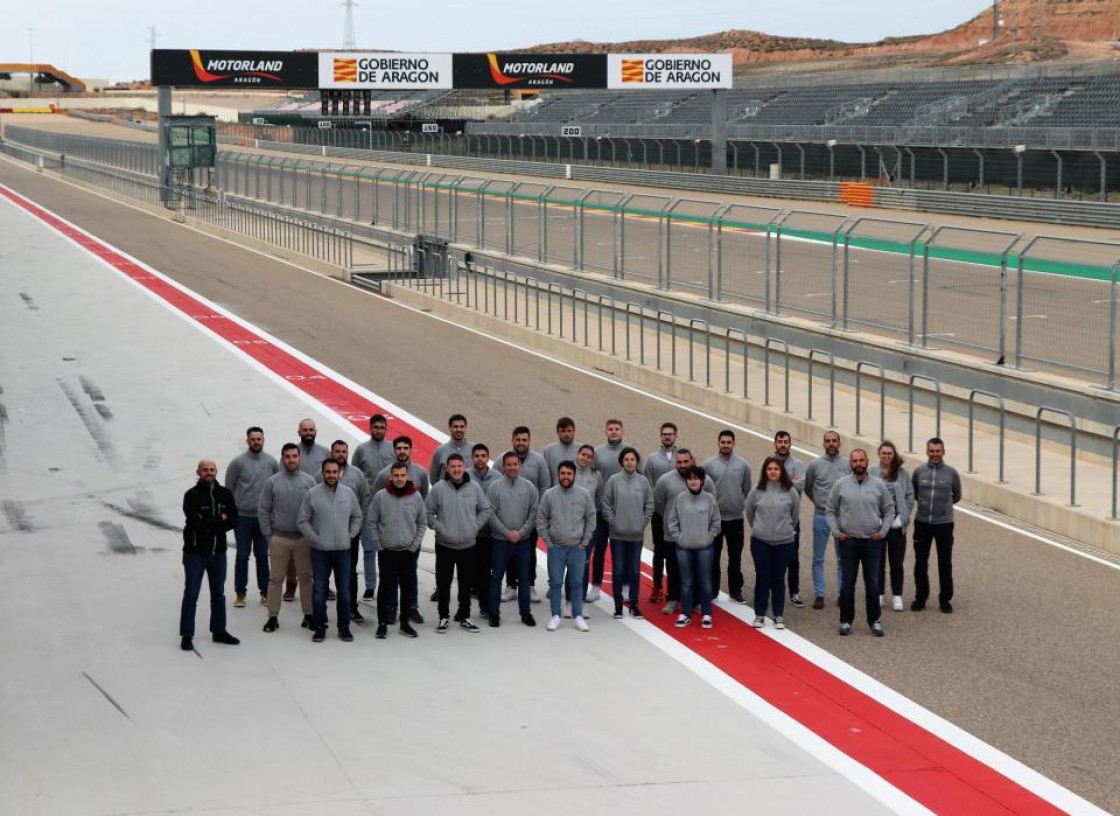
[319,51,451,91]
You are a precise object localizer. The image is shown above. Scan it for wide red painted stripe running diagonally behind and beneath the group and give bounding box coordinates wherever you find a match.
[0,186,1062,815]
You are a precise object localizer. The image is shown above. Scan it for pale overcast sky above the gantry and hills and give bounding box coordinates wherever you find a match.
[0,0,990,82]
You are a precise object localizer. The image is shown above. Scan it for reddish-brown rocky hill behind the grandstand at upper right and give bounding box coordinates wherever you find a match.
[523,0,1120,74]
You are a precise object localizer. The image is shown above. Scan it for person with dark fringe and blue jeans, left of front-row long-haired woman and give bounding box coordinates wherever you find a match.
[657,466,719,629]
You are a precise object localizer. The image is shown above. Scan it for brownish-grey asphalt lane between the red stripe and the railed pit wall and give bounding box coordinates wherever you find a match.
[0,154,1120,810]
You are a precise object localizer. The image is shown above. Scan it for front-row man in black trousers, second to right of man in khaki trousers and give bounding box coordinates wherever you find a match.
[364,462,428,639]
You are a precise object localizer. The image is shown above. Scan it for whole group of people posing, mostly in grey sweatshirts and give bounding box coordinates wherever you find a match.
[179,414,961,650]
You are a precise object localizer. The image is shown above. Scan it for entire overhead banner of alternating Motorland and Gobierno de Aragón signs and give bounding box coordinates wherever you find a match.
[151,48,731,91]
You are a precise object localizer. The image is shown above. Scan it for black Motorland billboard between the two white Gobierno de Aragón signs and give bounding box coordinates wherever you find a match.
[455,54,607,90]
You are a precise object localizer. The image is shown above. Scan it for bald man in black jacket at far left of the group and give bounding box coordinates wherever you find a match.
[179,459,241,651]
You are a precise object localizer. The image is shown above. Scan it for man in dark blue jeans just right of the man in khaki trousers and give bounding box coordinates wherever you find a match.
[297,459,362,643]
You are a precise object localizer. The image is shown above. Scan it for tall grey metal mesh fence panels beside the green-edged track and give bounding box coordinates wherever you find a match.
[4,131,1120,388]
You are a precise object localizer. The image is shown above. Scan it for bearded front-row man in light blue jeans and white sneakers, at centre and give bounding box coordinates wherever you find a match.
[536,459,595,631]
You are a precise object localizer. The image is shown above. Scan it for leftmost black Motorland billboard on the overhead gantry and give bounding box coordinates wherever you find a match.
[151,48,319,88]
